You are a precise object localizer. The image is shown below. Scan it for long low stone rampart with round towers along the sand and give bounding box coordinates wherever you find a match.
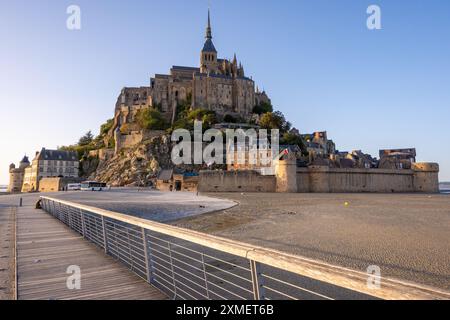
[199,161,439,193]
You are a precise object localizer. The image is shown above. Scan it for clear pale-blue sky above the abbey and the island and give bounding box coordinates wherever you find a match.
[0,0,450,184]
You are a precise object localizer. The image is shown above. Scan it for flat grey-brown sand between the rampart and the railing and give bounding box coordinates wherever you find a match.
[172,193,450,290]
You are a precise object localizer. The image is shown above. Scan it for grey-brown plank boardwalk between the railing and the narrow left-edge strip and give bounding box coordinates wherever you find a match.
[17,206,167,300]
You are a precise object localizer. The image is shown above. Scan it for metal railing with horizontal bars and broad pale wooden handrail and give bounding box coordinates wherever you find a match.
[41,197,450,300]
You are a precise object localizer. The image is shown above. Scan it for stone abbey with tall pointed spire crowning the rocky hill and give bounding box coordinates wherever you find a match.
[115,11,270,125]
